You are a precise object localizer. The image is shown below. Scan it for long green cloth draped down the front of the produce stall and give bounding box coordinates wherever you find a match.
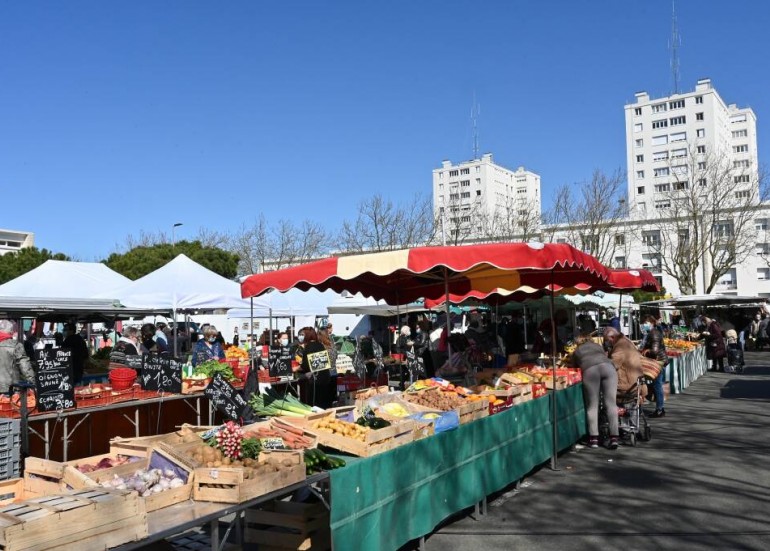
[329,384,585,551]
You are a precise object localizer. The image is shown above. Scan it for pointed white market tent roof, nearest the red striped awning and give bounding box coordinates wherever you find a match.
[99,254,249,312]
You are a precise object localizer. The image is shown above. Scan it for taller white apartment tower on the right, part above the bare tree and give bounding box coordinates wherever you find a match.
[625,79,758,219]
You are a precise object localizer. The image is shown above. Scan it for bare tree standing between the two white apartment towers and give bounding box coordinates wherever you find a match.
[542,169,628,265]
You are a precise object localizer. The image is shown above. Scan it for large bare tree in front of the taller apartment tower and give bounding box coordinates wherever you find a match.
[643,146,767,294]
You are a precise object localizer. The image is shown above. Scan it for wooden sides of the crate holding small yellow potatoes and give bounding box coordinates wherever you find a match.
[284,410,415,457]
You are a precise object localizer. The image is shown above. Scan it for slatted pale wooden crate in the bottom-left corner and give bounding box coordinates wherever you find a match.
[0,488,147,551]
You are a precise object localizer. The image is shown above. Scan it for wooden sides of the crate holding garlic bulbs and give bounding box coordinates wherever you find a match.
[73,443,196,513]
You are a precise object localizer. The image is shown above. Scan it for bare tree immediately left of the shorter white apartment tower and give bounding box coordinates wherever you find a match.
[338,194,433,252]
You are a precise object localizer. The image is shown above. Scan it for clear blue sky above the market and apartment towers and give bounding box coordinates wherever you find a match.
[0,0,770,261]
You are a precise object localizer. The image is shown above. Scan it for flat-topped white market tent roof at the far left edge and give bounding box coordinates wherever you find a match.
[0,260,131,299]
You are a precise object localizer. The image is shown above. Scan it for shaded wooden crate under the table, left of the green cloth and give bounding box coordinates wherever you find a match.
[243,500,331,551]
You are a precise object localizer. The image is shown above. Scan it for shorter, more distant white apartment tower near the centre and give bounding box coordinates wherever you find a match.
[433,153,541,239]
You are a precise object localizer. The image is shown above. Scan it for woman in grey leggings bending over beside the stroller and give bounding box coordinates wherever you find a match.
[572,339,618,450]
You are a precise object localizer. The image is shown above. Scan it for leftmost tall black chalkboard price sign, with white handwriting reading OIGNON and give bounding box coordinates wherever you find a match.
[35,348,75,411]
